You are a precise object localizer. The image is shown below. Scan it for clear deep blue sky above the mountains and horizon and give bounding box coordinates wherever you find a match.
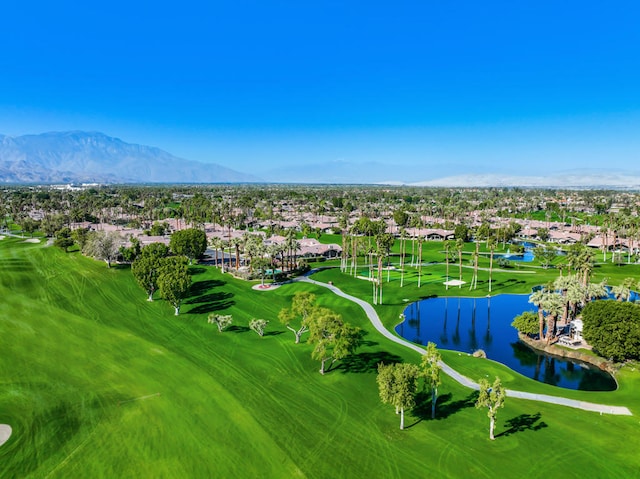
[0,0,640,181]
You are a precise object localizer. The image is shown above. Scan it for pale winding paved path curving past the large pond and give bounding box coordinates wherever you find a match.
[294,271,632,416]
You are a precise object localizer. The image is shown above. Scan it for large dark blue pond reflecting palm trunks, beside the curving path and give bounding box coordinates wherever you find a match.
[395,294,617,391]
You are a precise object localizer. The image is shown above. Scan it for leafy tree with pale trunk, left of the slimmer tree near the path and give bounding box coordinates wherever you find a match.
[376,363,420,430]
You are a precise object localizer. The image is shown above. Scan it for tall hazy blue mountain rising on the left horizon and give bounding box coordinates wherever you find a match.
[0,131,260,183]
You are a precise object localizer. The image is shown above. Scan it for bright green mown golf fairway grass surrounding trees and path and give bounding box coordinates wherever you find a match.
[0,238,640,478]
